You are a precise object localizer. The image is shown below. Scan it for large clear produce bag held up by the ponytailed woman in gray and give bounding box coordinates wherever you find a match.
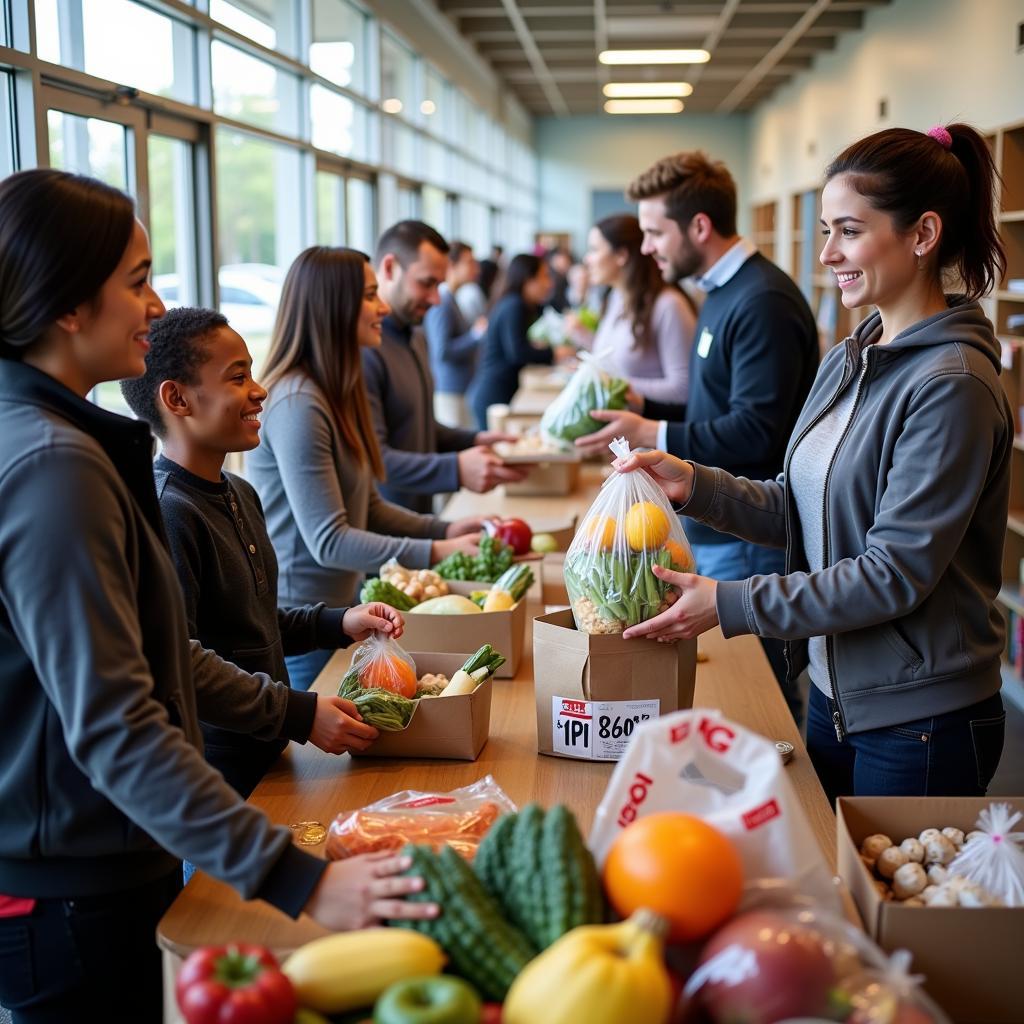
[565,437,693,633]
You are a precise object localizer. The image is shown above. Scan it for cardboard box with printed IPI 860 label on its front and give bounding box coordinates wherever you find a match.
[534,610,697,761]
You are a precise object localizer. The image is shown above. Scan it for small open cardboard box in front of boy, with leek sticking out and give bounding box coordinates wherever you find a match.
[354,655,492,761]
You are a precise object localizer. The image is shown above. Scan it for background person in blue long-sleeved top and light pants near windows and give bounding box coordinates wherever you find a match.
[423,242,487,428]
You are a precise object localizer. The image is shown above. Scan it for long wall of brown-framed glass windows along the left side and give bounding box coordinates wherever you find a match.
[0,0,537,395]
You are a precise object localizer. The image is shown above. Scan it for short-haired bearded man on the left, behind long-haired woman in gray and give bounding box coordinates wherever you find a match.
[362,220,527,512]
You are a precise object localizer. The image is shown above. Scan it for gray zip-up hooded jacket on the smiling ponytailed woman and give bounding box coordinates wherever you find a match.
[681,300,1014,735]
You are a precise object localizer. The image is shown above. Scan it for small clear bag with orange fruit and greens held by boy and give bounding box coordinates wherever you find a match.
[338,633,416,732]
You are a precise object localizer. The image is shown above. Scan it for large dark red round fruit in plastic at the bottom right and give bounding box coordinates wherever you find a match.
[687,910,838,1024]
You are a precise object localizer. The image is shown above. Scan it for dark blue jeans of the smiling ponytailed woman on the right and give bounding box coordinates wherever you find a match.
[807,686,1007,806]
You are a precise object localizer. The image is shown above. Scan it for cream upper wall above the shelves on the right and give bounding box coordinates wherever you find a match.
[745,0,1024,265]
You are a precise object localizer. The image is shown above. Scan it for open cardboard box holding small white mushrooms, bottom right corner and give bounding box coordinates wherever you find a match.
[836,797,1024,1024]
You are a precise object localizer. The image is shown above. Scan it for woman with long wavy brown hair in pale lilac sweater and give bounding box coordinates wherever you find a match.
[584,213,696,406]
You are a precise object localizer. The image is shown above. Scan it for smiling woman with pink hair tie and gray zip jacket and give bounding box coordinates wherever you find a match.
[618,125,1014,798]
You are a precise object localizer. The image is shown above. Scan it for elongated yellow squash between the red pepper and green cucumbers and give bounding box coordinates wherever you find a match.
[284,928,444,1014]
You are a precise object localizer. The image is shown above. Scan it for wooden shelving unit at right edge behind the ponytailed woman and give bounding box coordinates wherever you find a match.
[985,114,1024,705]
